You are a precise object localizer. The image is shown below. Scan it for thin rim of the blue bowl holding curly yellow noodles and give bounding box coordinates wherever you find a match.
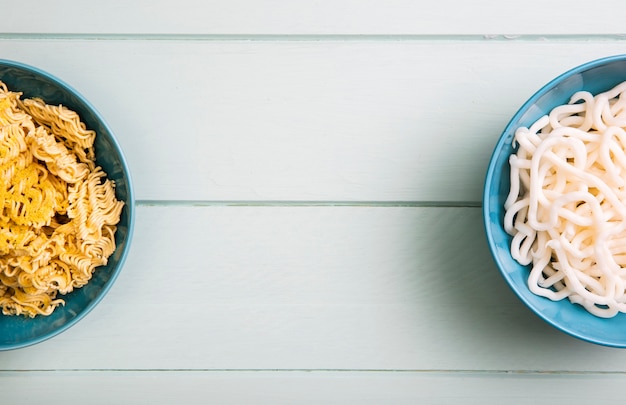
[0,58,135,352]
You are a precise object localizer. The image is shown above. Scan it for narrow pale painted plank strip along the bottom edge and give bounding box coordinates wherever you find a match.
[0,371,626,405]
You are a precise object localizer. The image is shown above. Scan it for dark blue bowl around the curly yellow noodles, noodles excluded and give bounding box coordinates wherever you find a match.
[0,60,135,350]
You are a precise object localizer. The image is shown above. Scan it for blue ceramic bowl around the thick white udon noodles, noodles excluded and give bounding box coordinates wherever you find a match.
[483,55,626,348]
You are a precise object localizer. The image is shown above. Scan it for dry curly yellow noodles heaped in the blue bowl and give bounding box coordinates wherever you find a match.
[0,81,124,317]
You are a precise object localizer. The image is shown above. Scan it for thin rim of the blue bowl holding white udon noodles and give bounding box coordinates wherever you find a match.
[482,54,626,348]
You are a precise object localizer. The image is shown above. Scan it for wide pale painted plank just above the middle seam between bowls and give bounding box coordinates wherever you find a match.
[0,39,623,201]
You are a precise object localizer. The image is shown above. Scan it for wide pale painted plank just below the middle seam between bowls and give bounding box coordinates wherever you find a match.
[0,206,626,372]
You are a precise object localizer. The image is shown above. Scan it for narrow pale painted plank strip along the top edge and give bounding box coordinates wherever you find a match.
[0,0,626,35]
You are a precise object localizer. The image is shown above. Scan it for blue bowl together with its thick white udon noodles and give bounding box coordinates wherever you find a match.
[483,55,626,348]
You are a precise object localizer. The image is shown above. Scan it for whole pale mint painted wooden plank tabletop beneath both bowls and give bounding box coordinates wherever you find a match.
[0,0,626,405]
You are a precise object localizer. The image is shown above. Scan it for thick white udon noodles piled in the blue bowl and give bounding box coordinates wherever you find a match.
[504,82,626,318]
